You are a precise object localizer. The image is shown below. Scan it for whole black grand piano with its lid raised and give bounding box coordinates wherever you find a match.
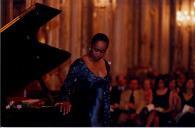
[0,3,71,127]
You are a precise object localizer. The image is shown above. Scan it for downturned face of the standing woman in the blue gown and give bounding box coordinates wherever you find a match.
[91,41,107,60]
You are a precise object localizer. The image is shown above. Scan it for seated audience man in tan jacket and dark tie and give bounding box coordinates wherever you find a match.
[119,78,144,126]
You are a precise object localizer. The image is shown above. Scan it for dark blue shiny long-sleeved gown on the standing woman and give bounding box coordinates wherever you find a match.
[61,58,110,127]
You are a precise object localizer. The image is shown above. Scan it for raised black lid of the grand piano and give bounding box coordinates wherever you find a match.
[0,4,71,96]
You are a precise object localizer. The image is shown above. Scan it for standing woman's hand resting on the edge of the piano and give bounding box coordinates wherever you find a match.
[55,101,72,115]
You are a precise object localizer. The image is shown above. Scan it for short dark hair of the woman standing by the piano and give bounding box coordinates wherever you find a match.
[91,33,109,47]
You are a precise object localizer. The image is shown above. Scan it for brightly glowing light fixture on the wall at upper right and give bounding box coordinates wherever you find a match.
[176,2,195,26]
